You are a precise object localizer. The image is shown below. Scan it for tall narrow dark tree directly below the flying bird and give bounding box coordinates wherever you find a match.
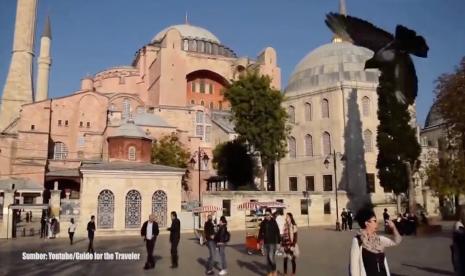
[376,70,421,203]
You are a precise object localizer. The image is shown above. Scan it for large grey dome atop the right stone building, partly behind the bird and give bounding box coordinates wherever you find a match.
[286,42,378,92]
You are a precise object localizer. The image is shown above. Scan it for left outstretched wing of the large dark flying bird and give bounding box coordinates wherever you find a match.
[325,13,394,52]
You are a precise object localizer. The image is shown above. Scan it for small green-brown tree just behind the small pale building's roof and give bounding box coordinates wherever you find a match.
[152,134,190,168]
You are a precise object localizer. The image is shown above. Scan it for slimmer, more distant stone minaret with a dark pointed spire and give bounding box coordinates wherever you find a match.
[35,17,52,101]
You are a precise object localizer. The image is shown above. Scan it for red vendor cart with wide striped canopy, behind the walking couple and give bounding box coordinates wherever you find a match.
[238,201,286,255]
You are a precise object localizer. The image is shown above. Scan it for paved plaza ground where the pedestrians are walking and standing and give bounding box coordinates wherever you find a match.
[0,224,453,276]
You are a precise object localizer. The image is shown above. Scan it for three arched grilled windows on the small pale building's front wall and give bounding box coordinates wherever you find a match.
[97,190,168,229]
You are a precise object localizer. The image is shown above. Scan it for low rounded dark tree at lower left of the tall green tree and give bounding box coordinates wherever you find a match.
[212,140,257,189]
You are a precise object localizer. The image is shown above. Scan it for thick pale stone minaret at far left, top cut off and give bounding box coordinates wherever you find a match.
[0,0,37,132]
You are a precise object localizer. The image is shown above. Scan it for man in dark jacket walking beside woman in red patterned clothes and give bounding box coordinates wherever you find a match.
[258,208,281,276]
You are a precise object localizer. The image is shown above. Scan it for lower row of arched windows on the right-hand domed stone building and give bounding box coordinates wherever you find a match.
[288,129,373,158]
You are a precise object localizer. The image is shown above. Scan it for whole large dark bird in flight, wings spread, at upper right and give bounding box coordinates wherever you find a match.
[325,13,429,105]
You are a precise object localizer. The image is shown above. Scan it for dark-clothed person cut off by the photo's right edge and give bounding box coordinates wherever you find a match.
[451,206,465,276]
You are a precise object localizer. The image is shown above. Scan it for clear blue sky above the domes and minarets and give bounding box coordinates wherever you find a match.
[0,0,465,124]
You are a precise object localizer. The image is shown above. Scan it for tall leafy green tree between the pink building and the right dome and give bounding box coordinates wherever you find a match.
[224,71,289,189]
